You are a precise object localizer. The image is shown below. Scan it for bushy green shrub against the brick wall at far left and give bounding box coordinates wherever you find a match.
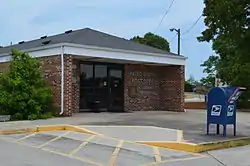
[0,50,52,120]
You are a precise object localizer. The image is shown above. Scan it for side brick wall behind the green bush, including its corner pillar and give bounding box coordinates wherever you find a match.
[0,55,75,116]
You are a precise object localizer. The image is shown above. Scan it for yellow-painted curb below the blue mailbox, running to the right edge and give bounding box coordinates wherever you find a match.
[136,137,250,153]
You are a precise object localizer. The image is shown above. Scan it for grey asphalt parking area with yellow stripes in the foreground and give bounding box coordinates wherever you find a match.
[0,131,217,166]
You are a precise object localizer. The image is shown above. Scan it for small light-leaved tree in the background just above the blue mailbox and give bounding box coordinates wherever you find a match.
[200,55,219,88]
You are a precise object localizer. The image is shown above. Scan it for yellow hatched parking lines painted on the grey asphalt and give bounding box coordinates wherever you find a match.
[0,131,208,166]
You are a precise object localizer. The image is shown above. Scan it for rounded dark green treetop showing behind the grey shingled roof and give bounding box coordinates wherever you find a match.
[130,32,170,52]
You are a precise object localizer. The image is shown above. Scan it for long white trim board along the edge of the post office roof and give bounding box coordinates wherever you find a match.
[0,43,187,65]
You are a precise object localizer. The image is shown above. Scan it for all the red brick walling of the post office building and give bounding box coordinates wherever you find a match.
[0,55,185,116]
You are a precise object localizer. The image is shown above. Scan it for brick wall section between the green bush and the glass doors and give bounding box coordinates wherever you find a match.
[41,55,80,116]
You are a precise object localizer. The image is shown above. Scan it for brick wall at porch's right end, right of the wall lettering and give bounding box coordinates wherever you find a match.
[159,65,185,112]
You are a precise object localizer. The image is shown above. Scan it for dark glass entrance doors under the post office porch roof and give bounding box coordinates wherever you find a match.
[80,63,124,111]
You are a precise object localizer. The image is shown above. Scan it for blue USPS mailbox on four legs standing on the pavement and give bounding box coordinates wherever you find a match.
[206,87,245,136]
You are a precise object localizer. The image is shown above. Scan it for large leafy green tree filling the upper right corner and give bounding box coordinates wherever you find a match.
[198,0,250,105]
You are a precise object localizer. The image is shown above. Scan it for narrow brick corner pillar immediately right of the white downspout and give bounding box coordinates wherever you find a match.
[64,55,73,116]
